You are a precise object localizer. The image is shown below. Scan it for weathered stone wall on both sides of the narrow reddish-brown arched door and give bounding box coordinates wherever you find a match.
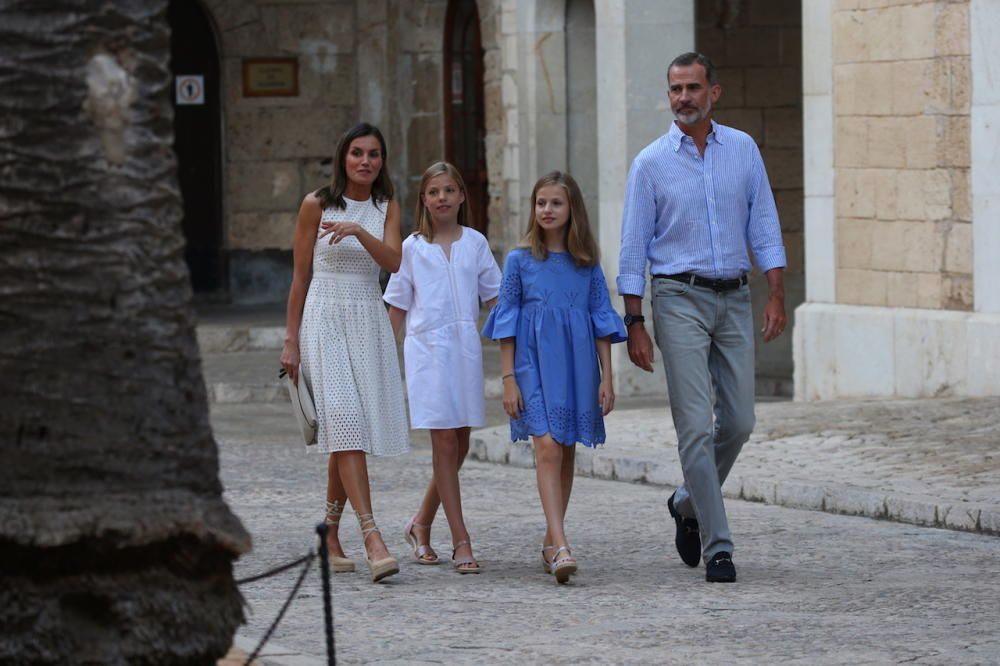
[198,0,517,302]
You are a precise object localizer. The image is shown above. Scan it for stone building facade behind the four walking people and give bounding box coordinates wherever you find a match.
[171,0,1000,399]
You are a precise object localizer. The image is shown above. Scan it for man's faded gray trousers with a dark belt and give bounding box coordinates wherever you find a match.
[653,278,754,562]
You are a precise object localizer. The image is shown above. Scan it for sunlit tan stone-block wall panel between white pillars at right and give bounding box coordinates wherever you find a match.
[833,0,973,310]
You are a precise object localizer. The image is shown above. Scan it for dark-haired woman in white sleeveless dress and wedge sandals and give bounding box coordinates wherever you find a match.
[281,123,409,581]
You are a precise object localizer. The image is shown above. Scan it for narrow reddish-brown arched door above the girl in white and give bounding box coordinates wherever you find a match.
[444,0,489,234]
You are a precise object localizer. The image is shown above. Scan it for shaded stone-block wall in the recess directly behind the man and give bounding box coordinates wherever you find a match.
[695,0,805,395]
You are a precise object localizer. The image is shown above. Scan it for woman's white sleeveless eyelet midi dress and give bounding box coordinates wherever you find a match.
[299,198,410,456]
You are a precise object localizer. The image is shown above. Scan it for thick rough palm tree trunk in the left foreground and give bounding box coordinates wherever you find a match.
[0,0,250,664]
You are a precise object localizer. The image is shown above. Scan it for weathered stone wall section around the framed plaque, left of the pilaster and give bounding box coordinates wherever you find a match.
[205,0,358,301]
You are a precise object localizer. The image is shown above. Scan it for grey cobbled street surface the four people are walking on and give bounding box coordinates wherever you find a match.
[213,403,1000,664]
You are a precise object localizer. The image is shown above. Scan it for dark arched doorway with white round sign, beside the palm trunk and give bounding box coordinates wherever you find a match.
[167,0,226,295]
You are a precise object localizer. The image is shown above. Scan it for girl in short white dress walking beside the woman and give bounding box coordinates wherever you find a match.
[384,162,502,574]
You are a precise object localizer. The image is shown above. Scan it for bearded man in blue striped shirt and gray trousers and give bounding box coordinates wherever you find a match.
[618,53,785,582]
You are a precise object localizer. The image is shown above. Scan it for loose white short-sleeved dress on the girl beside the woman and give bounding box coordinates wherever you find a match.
[383,227,502,429]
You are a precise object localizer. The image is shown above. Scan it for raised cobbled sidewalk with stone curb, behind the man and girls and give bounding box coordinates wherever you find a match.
[470,399,1000,535]
